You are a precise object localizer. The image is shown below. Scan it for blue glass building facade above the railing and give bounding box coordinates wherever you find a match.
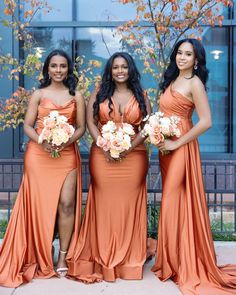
[0,0,236,160]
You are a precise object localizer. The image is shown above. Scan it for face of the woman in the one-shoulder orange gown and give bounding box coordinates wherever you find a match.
[176,42,197,71]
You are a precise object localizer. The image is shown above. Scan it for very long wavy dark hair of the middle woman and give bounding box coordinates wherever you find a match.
[93,52,147,119]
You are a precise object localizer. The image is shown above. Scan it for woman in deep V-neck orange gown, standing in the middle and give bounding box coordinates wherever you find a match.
[68,52,150,283]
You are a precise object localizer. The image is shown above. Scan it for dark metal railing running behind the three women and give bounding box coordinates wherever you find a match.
[0,158,236,236]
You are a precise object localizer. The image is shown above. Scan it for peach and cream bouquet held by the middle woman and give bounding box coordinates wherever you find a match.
[96,121,135,159]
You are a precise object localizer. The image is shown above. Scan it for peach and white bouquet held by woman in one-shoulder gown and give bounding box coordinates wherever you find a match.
[142,112,181,154]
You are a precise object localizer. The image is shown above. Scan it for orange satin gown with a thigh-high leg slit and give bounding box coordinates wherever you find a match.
[0,98,81,287]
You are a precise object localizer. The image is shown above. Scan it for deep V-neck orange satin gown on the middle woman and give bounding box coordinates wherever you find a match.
[68,97,148,283]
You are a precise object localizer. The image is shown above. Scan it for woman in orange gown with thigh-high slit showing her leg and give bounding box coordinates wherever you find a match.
[0,50,85,287]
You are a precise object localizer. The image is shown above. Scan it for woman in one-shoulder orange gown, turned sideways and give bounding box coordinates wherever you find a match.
[152,39,236,295]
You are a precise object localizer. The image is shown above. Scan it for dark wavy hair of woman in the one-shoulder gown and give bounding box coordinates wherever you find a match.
[160,38,209,92]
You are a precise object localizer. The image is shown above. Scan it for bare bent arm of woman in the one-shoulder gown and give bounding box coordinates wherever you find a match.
[158,77,212,151]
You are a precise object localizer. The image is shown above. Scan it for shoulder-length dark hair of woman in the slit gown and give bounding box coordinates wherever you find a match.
[39,49,78,96]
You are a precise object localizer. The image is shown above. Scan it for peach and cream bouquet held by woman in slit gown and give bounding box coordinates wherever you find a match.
[38,111,75,158]
